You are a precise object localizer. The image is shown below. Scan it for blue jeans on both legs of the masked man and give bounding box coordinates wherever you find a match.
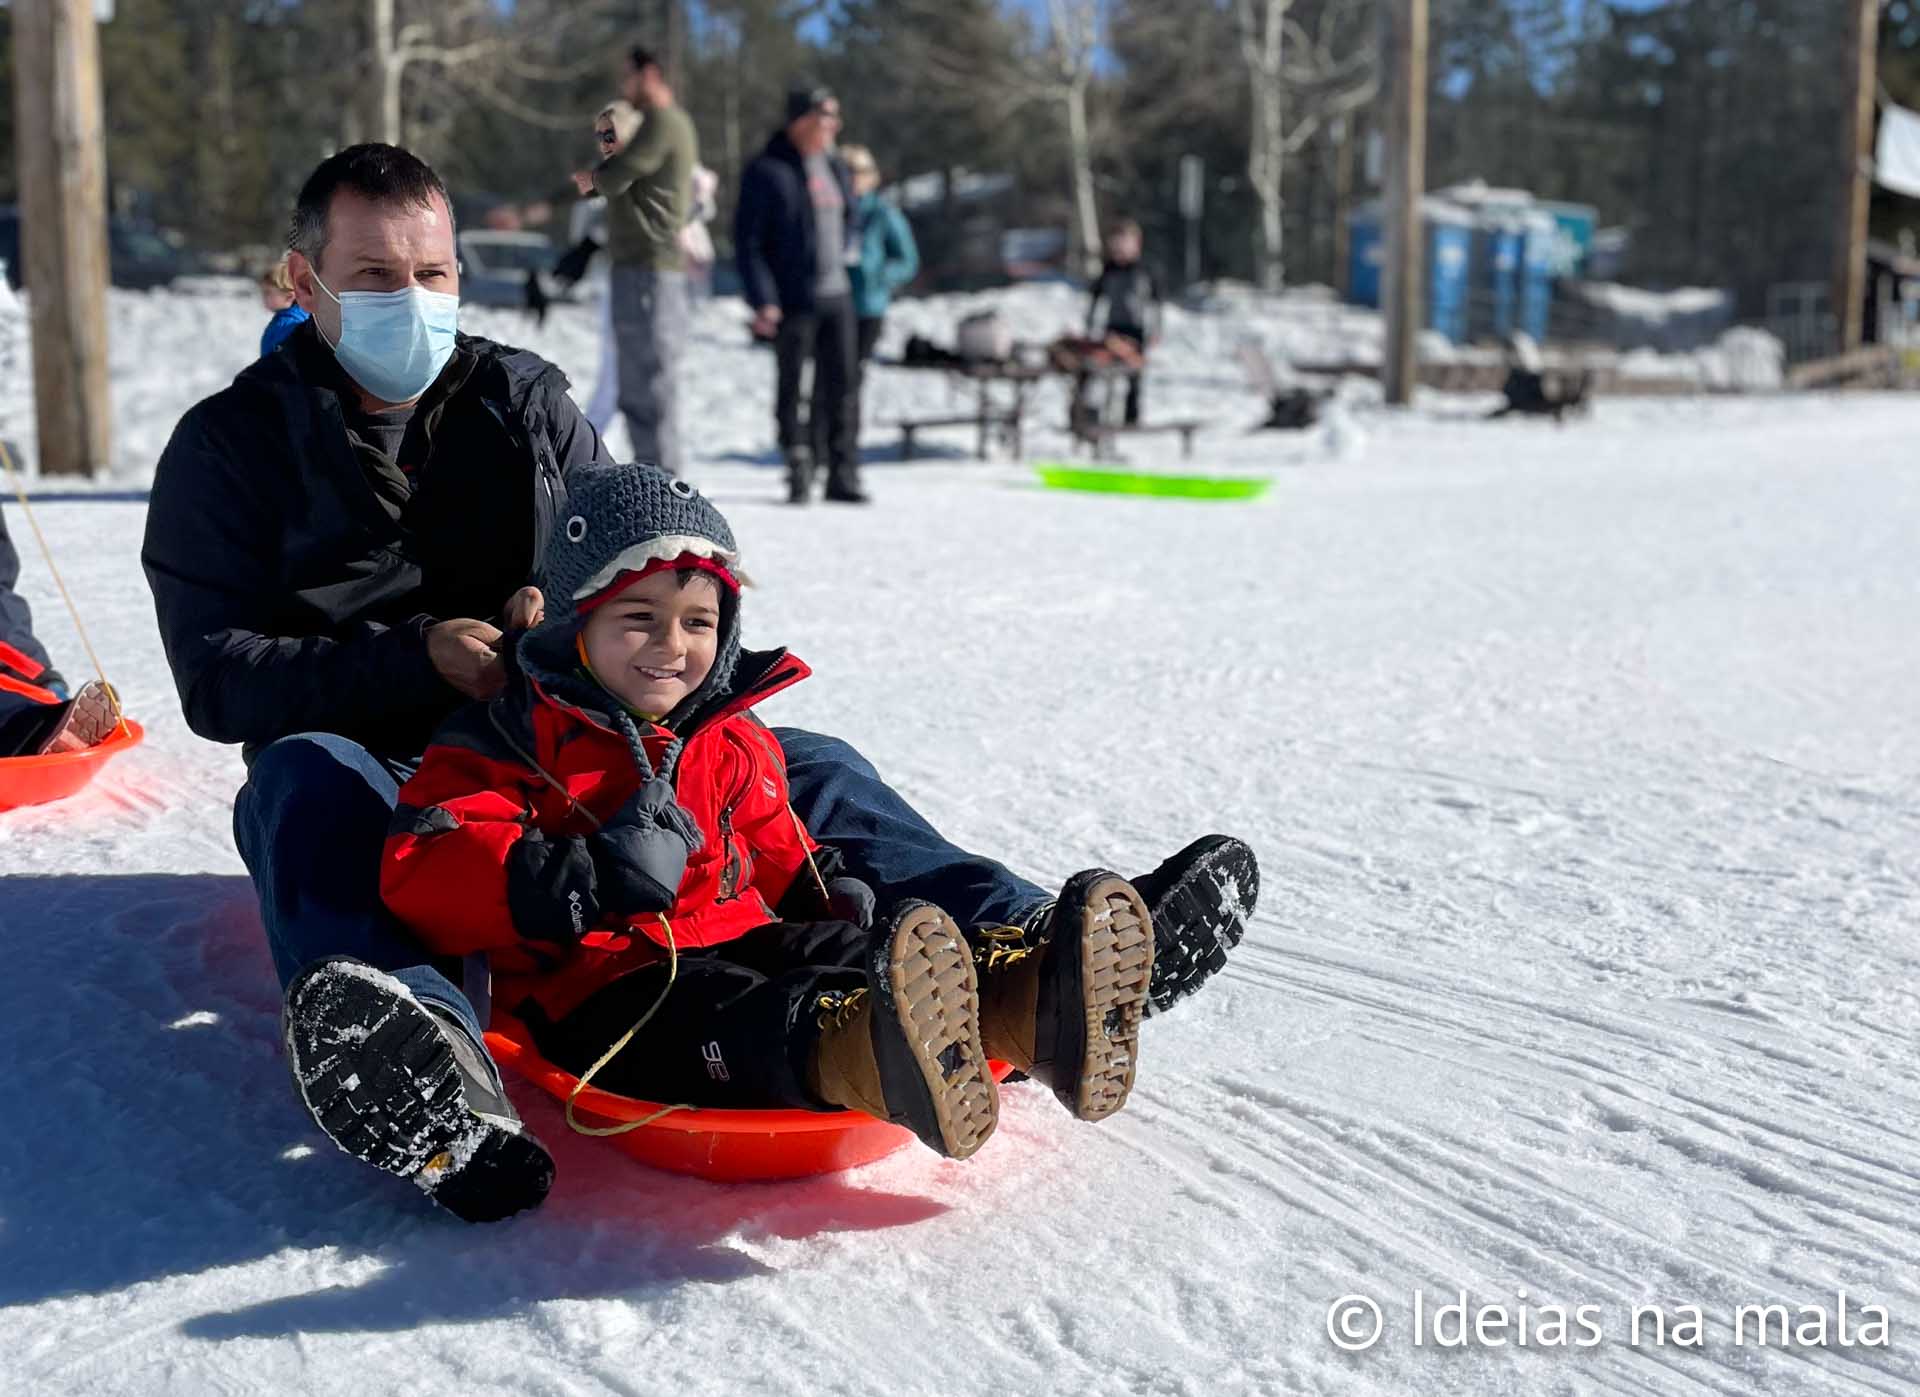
[234,727,1046,1040]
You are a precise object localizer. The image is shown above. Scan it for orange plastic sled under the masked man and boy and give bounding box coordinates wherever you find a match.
[486,1009,1010,1184]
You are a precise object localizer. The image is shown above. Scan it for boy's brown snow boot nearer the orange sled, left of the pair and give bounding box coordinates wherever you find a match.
[806,902,1000,1159]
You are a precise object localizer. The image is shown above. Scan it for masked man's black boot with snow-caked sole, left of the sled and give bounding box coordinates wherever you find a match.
[280,956,553,1222]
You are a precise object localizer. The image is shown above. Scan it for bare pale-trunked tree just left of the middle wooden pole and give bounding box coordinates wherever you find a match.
[1235,0,1380,292]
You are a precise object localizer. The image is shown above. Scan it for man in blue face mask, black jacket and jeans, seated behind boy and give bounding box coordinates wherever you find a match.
[140,144,1258,1222]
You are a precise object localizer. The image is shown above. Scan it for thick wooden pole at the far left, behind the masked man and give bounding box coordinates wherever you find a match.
[13,0,111,476]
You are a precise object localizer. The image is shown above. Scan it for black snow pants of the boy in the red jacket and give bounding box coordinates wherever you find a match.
[516,921,870,1111]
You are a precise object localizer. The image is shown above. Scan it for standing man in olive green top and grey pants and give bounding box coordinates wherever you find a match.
[574,48,699,476]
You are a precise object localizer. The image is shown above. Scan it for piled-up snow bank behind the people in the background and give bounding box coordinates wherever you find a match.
[0,276,1778,487]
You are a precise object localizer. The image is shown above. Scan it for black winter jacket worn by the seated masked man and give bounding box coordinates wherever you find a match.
[140,324,605,758]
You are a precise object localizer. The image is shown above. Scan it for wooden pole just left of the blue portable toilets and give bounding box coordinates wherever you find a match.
[1380,0,1428,407]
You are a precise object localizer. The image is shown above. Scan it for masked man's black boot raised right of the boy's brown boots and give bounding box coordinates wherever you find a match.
[1133,835,1260,1013]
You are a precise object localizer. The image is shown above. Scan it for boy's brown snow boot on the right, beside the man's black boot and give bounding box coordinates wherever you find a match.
[977,869,1154,1121]
